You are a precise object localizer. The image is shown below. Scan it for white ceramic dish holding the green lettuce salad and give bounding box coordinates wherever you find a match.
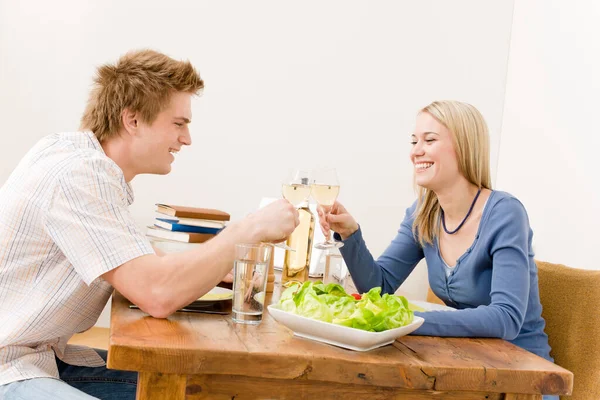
[267,304,425,351]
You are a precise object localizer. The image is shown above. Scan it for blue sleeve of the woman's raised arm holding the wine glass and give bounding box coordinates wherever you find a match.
[335,202,424,293]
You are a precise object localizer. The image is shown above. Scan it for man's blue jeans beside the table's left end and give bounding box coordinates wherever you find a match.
[0,350,137,400]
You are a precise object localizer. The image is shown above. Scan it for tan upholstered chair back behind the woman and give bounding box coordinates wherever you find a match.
[536,261,600,400]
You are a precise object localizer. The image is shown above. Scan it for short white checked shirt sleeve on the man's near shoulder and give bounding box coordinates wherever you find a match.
[45,158,154,285]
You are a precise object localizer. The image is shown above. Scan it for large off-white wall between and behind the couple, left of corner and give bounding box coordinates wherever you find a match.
[0,0,513,323]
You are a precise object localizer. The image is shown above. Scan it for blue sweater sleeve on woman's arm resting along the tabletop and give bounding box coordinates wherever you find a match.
[413,198,531,340]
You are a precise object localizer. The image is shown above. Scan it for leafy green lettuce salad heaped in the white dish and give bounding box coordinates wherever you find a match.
[277,281,414,332]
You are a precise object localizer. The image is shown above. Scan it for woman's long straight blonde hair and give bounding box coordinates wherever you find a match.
[413,100,492,246]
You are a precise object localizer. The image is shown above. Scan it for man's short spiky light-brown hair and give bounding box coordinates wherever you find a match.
[81,50,204,142]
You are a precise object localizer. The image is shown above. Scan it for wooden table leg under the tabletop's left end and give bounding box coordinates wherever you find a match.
[136,372,187,400]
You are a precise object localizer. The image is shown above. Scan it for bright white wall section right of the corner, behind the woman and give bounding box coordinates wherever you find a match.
[497,0,600,269]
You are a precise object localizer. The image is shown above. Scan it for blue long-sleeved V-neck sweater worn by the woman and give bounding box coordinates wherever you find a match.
[335,191,553,361]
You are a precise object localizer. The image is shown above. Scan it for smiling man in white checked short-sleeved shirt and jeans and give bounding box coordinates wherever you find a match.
[0,50,298,399]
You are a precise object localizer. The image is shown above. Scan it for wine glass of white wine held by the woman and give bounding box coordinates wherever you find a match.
[310,168,344,250]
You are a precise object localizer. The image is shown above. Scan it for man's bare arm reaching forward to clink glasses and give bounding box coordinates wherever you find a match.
[102,200,298,318]
